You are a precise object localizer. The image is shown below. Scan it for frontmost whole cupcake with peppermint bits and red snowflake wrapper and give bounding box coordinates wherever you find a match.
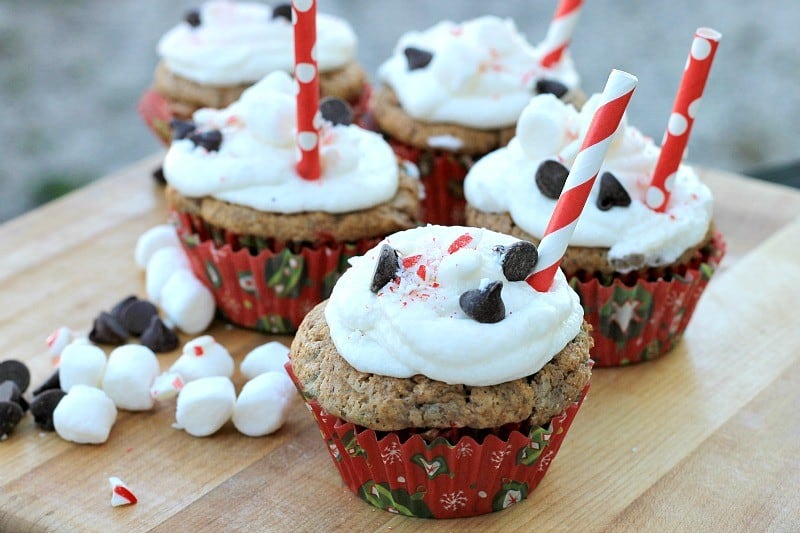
[287,225,592,518]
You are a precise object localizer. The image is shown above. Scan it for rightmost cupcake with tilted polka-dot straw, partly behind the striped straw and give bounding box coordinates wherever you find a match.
[464,95,724,366]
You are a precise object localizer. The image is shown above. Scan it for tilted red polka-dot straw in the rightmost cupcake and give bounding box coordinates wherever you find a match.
[645,28,722,213]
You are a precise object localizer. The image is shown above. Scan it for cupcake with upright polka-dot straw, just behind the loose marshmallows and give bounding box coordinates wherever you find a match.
[164,72,419,333]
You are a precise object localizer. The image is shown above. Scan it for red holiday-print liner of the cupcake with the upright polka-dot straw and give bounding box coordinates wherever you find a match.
[172,212,380,334]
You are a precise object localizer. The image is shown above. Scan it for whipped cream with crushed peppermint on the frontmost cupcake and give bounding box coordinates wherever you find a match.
[325,226,583,386]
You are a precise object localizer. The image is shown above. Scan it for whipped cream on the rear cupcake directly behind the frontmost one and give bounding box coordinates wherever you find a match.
[378,16,579,129]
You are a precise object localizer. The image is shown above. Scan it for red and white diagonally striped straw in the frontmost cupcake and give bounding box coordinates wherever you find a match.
[526,70,637,292]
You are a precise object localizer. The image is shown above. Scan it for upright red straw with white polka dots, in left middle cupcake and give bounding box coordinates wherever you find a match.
[292,0,320,180]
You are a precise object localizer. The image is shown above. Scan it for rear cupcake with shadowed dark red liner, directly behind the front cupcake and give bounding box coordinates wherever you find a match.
[369,16,584,225]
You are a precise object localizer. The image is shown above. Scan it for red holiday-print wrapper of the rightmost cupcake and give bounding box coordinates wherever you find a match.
[570,232,725,367]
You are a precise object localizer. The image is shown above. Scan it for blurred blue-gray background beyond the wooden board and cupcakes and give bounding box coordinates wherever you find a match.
[0,0,800,220]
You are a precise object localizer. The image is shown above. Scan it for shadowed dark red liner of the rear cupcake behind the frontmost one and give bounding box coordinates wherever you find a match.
[389,139,477,226]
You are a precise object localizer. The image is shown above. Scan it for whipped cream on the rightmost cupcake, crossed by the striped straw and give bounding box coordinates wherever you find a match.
[464,95,713,272]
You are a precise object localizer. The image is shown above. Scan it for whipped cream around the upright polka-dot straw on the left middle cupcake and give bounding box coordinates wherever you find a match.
[164,72,399,213]
